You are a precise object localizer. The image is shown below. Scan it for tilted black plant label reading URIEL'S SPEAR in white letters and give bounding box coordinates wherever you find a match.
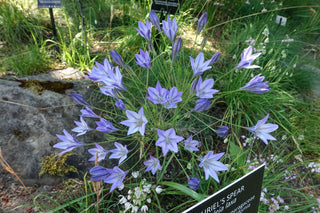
[183,165,264,213]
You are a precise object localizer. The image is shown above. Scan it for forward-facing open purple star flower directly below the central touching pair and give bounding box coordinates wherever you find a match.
[156,128,183,156]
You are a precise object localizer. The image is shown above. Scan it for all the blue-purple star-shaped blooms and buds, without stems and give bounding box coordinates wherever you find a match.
[54,11,278,196]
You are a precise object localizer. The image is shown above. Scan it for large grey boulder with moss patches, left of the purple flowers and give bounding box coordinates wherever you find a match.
[0,68,110,185]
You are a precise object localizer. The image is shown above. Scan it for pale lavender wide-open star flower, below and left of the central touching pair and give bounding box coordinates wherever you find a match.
[120,107,148,136]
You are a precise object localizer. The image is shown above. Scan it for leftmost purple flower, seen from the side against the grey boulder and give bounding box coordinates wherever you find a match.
[53,129,84,156]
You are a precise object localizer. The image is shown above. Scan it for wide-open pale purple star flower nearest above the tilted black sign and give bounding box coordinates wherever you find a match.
[199,151,228,183]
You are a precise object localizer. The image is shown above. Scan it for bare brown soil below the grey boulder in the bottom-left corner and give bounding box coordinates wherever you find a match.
[0,168,87,213]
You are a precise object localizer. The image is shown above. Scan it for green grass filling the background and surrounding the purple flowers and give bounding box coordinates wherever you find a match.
[4,0,320,212]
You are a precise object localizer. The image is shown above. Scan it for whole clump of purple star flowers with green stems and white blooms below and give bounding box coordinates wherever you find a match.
[54,11,278,212]
